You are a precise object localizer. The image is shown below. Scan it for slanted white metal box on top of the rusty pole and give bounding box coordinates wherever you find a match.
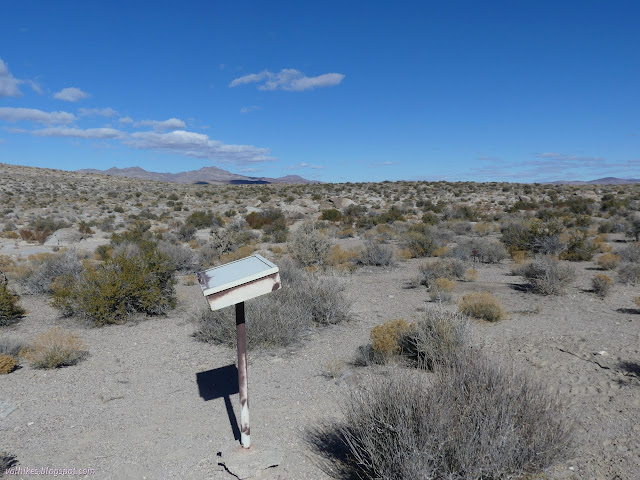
[196,254,280,310]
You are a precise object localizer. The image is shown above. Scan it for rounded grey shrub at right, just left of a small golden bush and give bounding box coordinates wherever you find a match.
[514,256,576,295]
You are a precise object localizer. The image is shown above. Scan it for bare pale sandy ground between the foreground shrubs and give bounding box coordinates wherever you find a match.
[0,251,640,480]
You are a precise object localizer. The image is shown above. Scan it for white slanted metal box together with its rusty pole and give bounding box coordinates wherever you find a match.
[197,254,280,448]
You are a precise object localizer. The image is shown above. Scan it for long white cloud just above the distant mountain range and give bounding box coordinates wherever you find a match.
[125,130,274,164]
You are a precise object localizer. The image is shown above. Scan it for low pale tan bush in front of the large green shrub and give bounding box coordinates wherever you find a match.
[20,327,87,369]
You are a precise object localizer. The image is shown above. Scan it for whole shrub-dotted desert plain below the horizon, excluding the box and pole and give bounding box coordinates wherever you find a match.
[0,164,640,480]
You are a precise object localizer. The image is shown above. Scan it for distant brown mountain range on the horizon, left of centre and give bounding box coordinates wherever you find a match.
[76,167,320,185]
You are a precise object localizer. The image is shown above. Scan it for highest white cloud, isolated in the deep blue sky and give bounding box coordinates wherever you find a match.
[229,68,345,92]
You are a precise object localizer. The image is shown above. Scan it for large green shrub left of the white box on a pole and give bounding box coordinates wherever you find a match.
[52,241,176,325]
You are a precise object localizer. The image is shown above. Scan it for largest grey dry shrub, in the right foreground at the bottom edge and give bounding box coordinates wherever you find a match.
[309,355,573,480]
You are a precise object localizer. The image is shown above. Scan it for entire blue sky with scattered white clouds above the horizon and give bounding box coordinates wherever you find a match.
[0,0,640,182]
